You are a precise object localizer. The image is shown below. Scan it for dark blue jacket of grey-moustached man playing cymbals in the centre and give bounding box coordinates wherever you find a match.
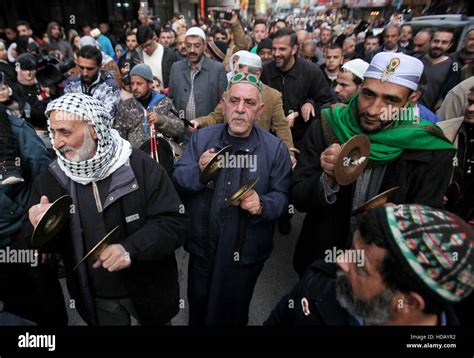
[172,124,291,264]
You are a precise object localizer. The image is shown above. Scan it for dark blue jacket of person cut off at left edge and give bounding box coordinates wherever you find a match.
[0,116,51,247]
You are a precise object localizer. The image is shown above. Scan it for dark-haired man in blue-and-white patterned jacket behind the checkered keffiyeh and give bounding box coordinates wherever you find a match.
[64,46,120,118]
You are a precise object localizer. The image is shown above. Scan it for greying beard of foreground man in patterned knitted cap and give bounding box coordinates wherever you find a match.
[336,271,394,325]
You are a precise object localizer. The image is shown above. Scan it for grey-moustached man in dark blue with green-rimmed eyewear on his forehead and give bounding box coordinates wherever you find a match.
[172,73,291,326]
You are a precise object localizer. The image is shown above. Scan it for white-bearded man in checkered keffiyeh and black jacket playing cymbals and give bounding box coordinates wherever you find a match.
[22,93,186,325]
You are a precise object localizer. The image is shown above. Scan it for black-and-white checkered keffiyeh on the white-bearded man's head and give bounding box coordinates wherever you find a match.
[45,93,132,185]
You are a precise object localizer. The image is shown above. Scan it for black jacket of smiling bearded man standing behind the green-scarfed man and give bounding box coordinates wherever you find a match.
[261,57,332,146]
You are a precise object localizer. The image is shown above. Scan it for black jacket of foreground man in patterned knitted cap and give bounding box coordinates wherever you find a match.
[263,260,459,327]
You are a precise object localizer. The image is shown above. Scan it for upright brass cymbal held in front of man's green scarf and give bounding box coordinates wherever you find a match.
[334,134,370,185]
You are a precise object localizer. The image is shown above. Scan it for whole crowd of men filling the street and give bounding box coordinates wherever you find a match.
[0,12,474,326]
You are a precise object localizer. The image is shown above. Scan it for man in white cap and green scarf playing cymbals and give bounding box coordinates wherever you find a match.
[291,52,455,276]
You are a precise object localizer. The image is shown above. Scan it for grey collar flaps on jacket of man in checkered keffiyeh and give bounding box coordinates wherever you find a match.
[49,155,139,210]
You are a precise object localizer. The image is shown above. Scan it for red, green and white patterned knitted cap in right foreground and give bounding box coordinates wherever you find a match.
[378,205,474,302]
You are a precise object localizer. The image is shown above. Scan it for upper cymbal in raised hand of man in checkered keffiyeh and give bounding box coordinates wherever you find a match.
[31,195,72,247]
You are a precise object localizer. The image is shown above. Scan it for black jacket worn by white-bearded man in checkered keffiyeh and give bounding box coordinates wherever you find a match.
[22,150,187,325]
